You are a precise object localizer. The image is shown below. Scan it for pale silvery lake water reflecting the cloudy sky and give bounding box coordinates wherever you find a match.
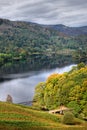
[0,65,74,103]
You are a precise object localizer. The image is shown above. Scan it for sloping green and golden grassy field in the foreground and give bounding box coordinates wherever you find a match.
[0,102,87,130]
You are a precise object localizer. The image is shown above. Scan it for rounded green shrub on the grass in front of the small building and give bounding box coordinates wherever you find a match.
[62,112,75,125]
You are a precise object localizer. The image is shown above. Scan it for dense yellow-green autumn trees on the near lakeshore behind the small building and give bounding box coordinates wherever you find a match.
[33,63,87,117]
